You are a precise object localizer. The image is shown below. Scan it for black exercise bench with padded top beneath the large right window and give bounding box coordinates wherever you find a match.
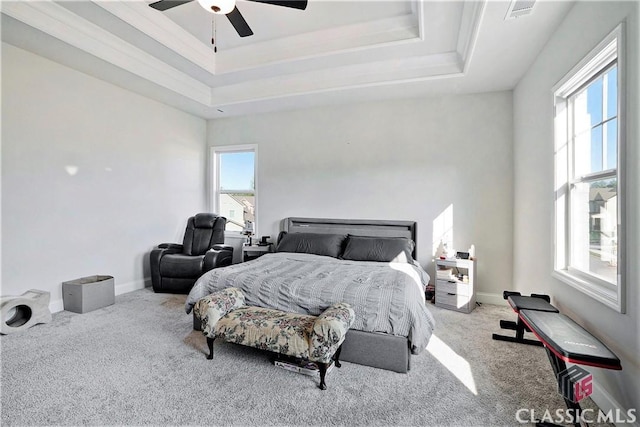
[494,295,622,426]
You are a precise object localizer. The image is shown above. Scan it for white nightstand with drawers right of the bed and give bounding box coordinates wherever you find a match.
[435,258,476,313]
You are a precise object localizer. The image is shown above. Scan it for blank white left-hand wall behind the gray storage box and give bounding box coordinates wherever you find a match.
[2,43,206,310]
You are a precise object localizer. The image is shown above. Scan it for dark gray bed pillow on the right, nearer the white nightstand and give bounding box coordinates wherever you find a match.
[342,235,415,263]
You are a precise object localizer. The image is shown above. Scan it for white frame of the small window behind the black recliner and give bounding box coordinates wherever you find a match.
[209,144,258,237]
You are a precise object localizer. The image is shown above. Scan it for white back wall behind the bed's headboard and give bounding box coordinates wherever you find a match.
[208,92,513,298]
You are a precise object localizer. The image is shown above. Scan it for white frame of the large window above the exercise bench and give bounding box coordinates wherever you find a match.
[552,23,627,313]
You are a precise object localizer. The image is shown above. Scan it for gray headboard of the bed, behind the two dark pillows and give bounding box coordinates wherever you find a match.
[282,217,418,259]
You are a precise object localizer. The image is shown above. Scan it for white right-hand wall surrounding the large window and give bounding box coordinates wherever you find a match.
[514,2,640,418]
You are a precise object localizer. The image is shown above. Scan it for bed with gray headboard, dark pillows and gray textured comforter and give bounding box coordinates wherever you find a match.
[185,218,435,372]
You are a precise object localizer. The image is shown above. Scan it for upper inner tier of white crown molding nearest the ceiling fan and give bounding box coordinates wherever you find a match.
[92,0,424,75]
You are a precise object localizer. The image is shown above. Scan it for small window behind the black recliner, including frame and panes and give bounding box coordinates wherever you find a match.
[212,146,256,233]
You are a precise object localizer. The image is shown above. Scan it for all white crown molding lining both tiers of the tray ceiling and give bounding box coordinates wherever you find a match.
[1,0,486,115]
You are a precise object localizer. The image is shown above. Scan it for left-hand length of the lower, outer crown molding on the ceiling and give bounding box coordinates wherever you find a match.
[2,1,211,105]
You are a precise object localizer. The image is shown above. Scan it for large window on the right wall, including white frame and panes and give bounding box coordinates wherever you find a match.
[554,26,624,312]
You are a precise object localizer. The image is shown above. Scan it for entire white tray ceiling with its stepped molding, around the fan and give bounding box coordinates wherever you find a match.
[1,0,573,118]
